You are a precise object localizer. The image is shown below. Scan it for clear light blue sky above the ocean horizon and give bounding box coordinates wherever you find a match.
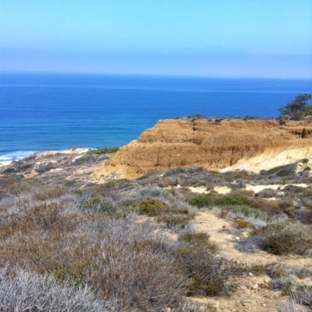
[0,0,312,79]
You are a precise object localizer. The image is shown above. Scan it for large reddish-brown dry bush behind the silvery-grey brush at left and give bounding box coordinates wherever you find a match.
[0,194,187,311]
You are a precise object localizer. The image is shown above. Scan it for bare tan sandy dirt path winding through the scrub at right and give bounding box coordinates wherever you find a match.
[190,211,312,312]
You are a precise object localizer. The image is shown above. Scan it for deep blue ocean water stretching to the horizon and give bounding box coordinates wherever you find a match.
[0,73,312,162]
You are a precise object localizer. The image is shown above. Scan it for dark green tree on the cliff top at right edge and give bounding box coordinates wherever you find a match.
[278,94,312,120]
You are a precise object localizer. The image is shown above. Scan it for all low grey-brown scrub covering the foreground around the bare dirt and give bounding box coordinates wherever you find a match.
[0,154,312,312]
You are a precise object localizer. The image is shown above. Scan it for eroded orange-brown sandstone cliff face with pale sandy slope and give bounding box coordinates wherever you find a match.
[95,119,312,179]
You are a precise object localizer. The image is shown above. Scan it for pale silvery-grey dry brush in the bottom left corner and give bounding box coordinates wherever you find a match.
[0,269,118,312]
